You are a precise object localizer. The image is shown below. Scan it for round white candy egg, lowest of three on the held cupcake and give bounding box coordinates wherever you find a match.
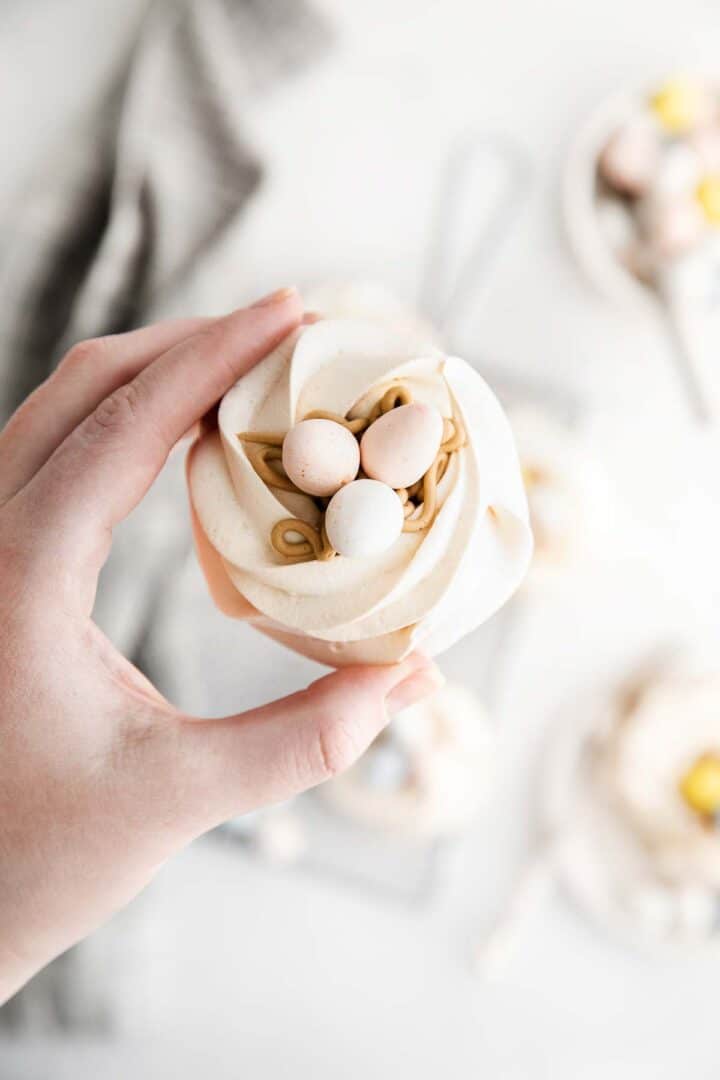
[325,480,405,558]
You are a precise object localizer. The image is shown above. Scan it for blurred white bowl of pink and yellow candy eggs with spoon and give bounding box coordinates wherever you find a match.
[563,75,720,421]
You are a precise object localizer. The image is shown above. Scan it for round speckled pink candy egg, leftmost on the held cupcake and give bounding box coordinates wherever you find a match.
[283,420,359,496]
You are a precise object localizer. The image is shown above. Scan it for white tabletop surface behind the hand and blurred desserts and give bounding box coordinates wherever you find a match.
[0,0,720,1080]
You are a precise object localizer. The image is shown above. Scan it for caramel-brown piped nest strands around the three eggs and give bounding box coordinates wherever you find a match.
[237,383,466,564]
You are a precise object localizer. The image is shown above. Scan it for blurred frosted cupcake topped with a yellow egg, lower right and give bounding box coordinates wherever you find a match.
[545,670,720,944]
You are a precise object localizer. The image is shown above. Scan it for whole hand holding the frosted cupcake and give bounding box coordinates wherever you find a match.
[0,289,440,1002]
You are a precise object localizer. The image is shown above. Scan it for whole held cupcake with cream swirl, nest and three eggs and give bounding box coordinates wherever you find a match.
[188,320,532,666]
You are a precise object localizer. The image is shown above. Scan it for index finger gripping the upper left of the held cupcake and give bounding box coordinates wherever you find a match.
[17,288,302,574]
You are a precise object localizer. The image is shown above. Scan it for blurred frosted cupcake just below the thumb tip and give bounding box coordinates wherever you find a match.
[320,684,494,839]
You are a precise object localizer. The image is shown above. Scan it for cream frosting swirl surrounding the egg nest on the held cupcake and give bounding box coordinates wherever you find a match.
[188,320,532,666]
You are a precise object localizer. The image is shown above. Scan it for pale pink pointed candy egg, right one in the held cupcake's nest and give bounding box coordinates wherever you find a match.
[361,403,443,487]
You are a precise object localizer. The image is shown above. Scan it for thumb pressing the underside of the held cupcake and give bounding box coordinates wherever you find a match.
[177,653,444,833]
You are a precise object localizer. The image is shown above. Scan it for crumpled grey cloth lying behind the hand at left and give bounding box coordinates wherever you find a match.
[0,0,329,1027]
